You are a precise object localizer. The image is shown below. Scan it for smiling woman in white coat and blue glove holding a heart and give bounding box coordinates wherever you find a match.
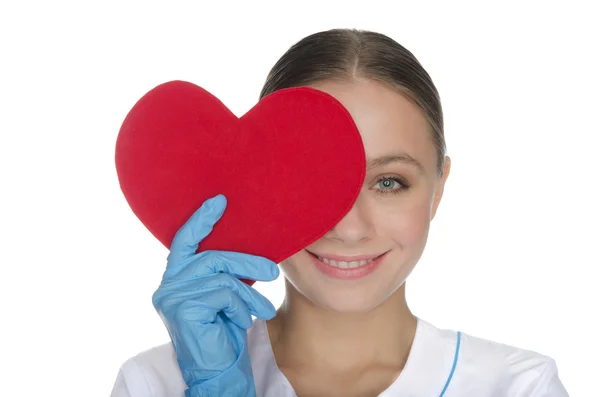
[113,29,567,397]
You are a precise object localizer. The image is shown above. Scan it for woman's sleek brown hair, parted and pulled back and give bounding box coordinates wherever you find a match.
[260,29,446,176]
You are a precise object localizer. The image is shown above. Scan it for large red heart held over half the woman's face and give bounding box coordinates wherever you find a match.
[115,81,366,285]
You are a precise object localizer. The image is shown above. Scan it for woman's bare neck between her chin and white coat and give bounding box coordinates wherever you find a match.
[267,280,417,372]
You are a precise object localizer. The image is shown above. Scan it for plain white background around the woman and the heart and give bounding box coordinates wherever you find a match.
[0,0,600,396]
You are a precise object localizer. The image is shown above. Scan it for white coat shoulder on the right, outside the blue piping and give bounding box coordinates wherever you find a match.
[418,323,568,397]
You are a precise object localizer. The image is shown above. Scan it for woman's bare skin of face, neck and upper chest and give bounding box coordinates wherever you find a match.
[267,78,450,396]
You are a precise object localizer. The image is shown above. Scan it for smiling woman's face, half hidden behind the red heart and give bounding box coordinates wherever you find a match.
[281,80,450,312]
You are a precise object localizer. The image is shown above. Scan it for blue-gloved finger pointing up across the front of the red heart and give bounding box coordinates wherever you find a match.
[167,194,227,268]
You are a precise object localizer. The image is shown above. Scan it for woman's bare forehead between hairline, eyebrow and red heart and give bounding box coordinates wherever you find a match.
[311,79,436,173]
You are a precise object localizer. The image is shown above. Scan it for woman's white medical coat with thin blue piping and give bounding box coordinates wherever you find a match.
[111,318,568,397]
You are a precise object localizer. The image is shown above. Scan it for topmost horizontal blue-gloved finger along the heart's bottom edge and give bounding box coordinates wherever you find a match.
[165,251,280,281]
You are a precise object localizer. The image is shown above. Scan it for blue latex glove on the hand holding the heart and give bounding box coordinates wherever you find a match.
[152,195,279,397]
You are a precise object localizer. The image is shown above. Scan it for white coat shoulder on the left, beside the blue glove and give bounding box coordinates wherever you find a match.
[111,342,187,397]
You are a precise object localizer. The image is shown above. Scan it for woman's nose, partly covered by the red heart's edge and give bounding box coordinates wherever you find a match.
[324,195,374,245]
